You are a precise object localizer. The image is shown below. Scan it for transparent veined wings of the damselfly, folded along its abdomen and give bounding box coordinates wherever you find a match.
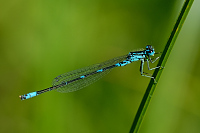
[52,55,127,93]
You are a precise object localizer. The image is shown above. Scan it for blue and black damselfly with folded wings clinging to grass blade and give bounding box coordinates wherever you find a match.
[19,45,160,100]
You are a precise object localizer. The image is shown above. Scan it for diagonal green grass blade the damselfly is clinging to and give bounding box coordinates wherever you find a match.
[130,0,194,133]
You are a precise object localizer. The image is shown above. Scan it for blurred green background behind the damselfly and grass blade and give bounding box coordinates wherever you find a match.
[0,0,200,133]
